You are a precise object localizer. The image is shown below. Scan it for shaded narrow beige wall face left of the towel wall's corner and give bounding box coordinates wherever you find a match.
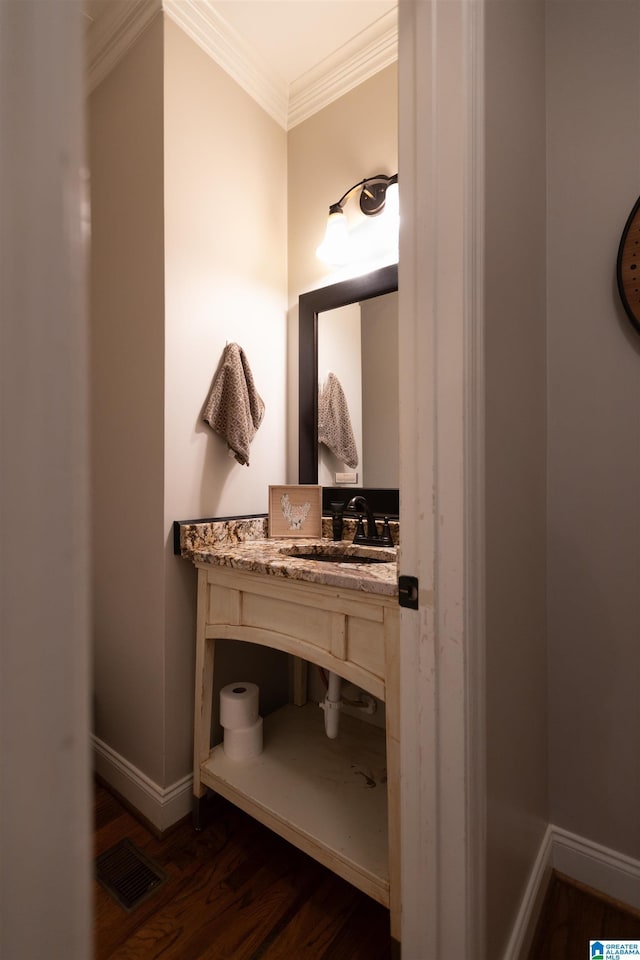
[89,18,165,783]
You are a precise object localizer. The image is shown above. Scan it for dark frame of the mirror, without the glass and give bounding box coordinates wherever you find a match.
[298,263,398,516]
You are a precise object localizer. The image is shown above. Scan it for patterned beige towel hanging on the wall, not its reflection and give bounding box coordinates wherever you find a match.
[203,343,264,466]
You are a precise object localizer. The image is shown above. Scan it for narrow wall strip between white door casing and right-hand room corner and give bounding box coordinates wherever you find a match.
[484,2,548,957]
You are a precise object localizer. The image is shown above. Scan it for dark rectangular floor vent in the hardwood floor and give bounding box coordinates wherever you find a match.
[96,839,168,912]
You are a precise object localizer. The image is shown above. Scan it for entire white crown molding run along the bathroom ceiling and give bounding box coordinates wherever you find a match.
[87,0,398,130]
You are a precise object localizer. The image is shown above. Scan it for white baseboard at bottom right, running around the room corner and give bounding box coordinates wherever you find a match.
[503,824,640,960]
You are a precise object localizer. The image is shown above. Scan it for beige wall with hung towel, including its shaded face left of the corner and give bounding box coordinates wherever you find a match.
[90,17,287,796]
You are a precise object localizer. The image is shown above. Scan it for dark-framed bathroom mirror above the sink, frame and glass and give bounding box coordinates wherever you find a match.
[298,264,399,515]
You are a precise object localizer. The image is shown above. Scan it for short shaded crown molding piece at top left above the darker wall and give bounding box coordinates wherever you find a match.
[86,0,162,92]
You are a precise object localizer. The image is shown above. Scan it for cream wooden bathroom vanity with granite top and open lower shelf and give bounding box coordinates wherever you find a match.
[181,518,400,941]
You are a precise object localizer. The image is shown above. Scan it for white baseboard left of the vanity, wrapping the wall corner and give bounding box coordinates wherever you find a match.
[91,736,193,830]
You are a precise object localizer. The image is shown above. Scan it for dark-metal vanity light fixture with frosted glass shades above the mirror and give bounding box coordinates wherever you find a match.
[316,173,398,266]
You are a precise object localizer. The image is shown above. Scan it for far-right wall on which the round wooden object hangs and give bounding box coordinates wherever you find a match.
[547,0,640,858]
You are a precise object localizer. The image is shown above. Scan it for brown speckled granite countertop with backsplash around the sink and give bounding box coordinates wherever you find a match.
[180,517,398,597]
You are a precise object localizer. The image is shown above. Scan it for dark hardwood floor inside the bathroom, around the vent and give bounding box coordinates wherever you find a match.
[94,785,391,960]
